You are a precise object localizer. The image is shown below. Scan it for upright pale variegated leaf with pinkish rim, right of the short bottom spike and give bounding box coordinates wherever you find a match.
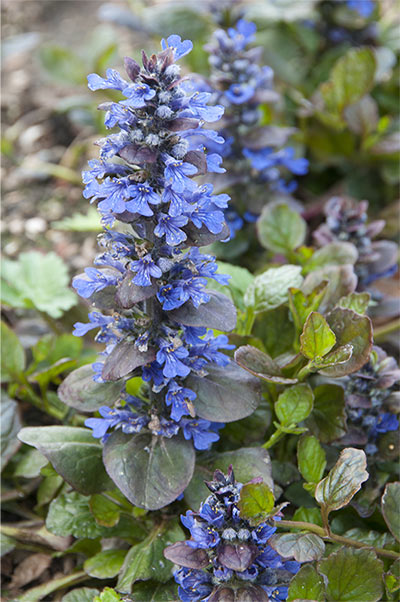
[315,447,369,516]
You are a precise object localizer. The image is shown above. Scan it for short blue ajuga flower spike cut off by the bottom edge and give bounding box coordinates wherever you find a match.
[164,466,300,602]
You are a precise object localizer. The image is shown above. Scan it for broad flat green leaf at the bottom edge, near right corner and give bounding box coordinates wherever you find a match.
[318,548,383,602]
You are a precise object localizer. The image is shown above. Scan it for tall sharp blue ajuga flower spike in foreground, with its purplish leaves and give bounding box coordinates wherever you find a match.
[26,35,259,508]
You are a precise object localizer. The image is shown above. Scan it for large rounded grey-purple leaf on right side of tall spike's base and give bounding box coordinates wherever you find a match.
[185,362,261,422]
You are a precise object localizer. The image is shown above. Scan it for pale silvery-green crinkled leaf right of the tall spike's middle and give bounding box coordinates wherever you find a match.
[244,264,303,313]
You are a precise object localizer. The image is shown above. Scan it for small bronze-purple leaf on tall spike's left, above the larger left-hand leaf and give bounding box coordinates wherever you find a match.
[101,341,156,381]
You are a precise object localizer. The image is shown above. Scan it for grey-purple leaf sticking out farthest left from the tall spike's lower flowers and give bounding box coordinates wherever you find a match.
[57,365,123,412]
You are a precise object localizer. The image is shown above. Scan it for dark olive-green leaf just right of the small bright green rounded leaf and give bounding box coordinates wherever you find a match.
[306,384,346,443]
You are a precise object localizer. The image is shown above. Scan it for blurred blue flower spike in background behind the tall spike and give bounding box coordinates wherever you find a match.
[200,3,308,257]
